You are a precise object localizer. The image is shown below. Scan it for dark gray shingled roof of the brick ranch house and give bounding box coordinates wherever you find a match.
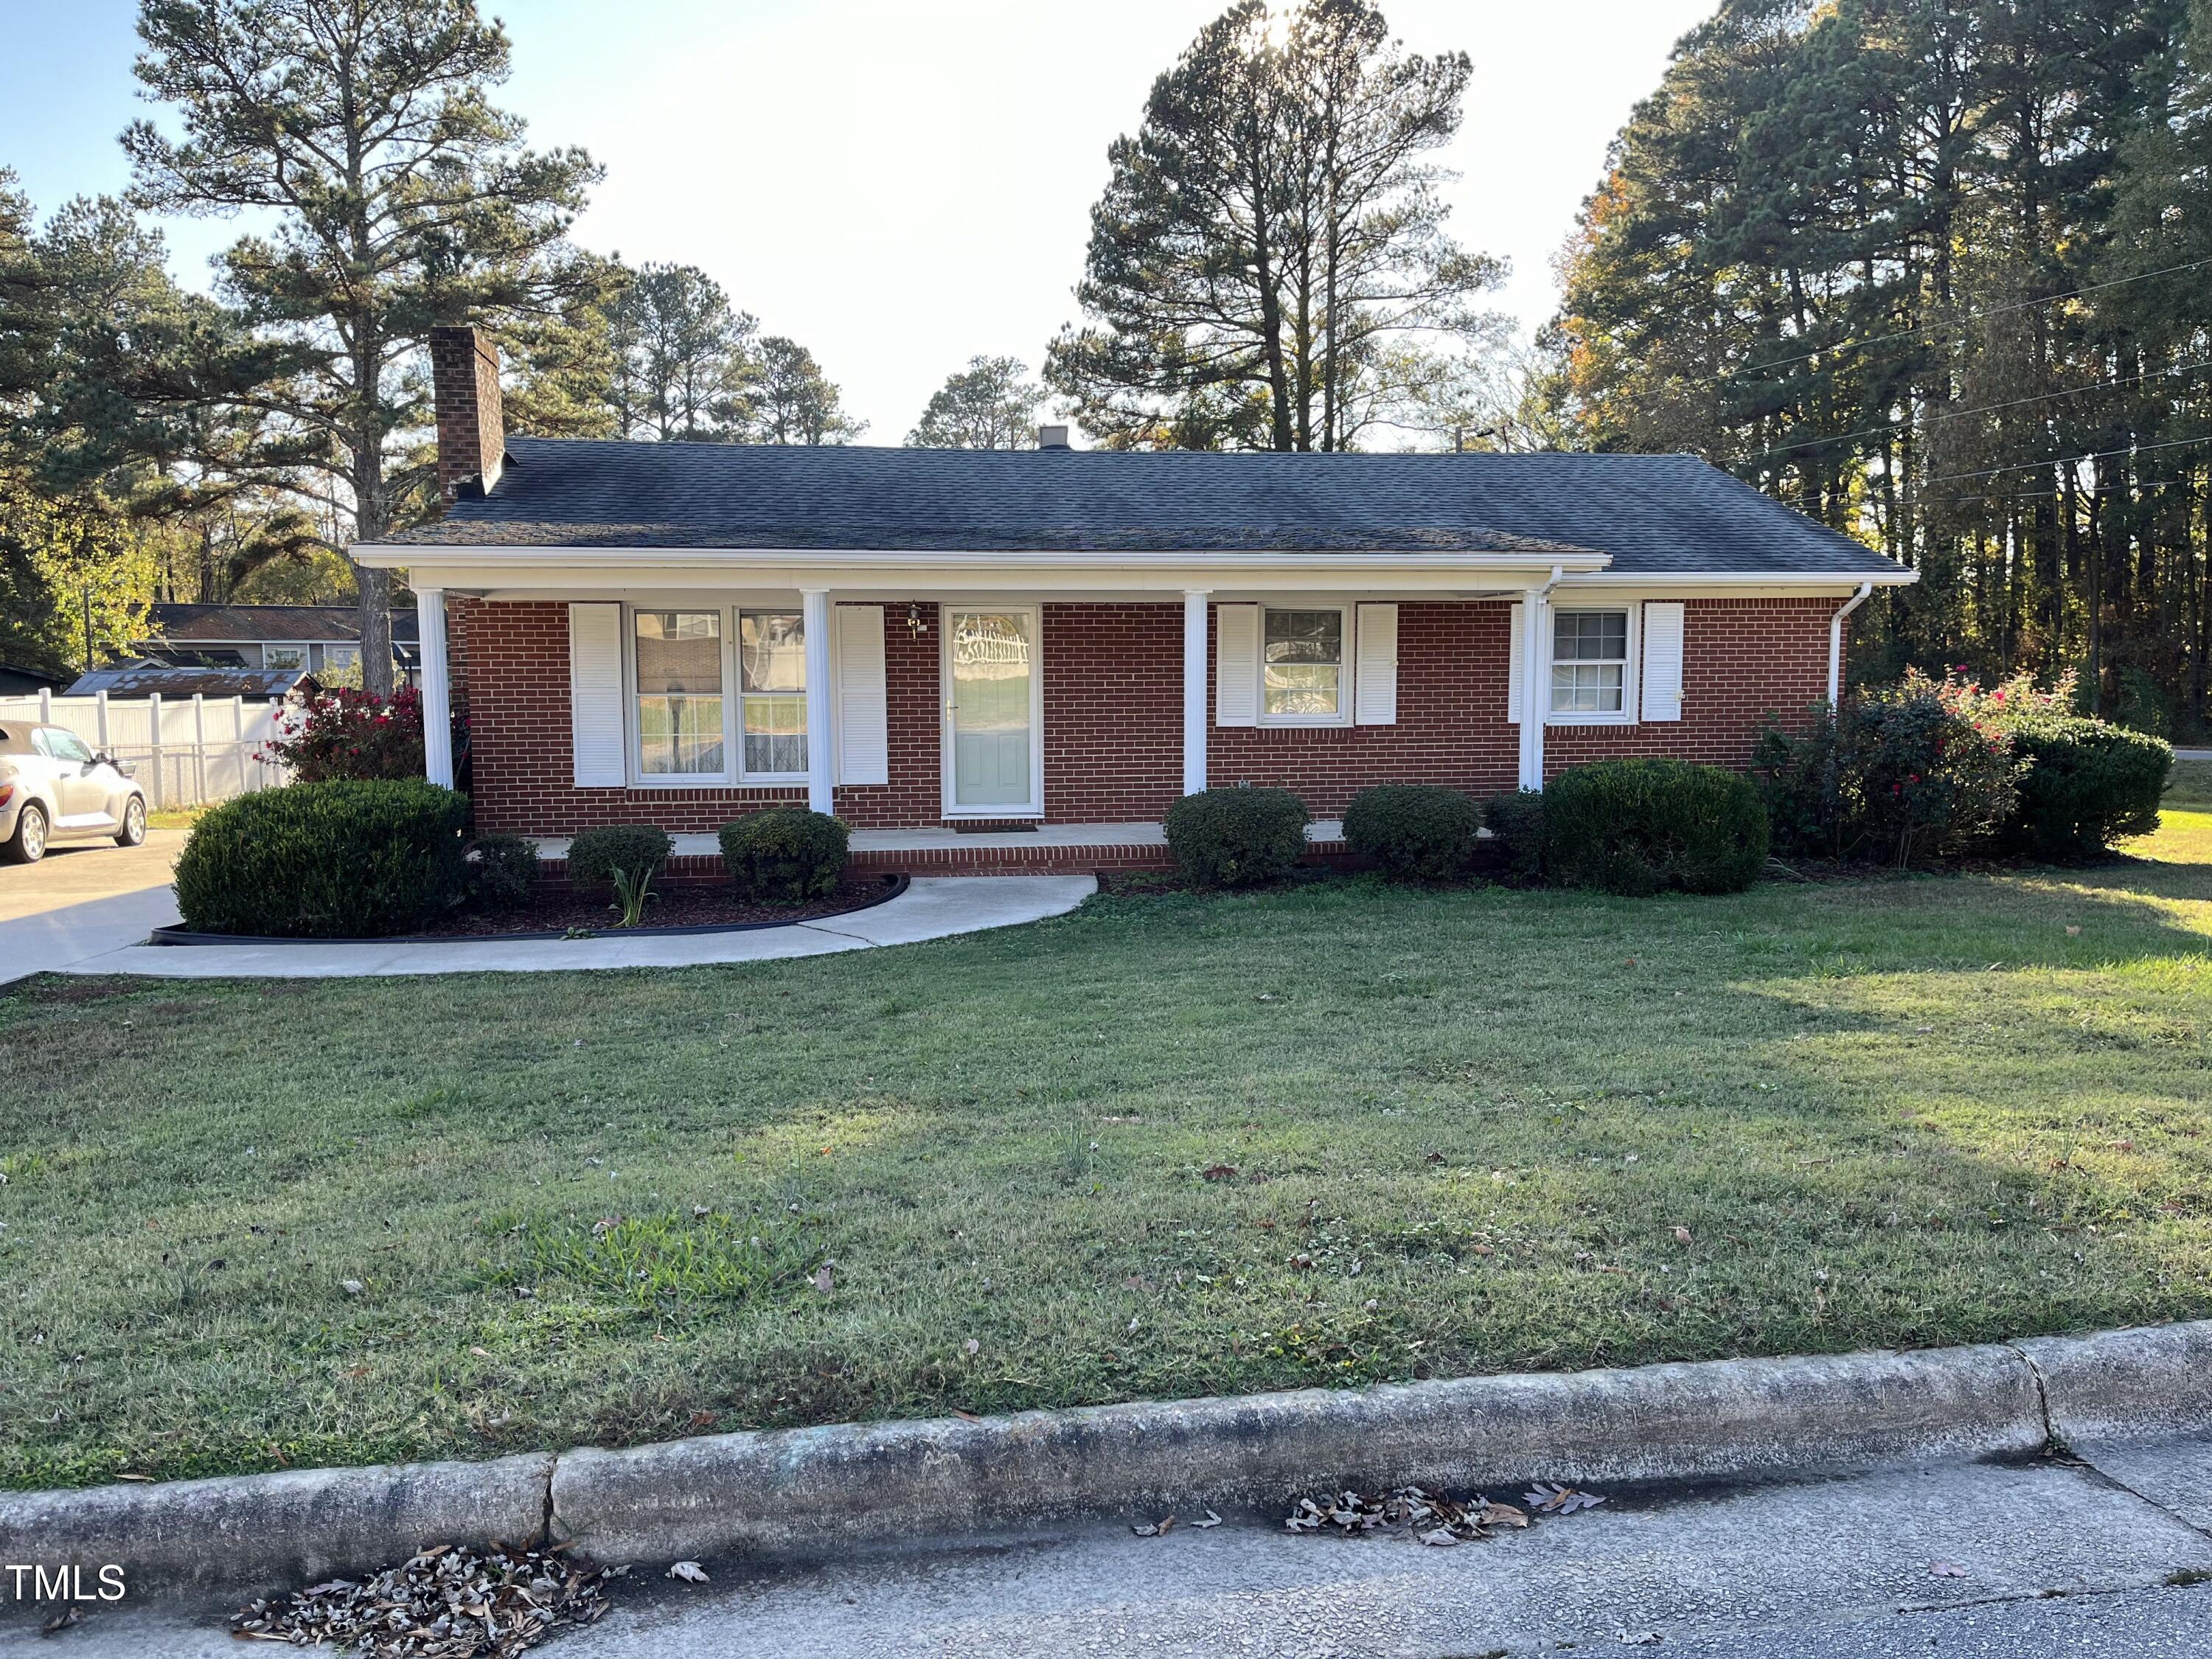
[392,438,1898,577]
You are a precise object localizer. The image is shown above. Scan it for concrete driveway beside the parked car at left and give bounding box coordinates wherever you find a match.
[0,830,186,984]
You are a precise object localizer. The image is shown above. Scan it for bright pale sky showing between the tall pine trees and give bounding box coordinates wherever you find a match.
[0,0,1717,442]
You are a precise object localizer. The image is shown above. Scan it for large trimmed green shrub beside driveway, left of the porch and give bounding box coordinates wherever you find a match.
[177,779,469,938]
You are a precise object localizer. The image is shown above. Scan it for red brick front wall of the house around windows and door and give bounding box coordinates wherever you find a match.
[449,599,1838,834]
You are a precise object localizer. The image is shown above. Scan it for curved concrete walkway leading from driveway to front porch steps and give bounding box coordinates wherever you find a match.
[62,876,1097,980]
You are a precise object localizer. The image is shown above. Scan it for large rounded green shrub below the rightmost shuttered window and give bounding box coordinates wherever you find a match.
[1544,759,1767,896]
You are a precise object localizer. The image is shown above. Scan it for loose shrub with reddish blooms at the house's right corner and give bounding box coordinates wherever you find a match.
[1754,668,2022,867]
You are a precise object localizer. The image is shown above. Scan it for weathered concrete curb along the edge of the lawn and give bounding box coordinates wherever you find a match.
[13,1321,2212,1588]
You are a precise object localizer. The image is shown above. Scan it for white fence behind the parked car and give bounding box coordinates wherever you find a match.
[0,692,285,812]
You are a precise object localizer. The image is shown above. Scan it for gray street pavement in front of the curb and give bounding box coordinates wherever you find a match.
[17,1442,2212,1659]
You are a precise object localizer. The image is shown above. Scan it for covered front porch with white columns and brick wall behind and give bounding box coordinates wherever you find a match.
[380,546,1679,845]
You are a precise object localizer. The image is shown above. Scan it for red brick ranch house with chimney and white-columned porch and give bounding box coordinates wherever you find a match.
[354,330,1913,872]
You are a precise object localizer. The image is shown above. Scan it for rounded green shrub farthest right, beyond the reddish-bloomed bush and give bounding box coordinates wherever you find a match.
[2000,712,2174,858]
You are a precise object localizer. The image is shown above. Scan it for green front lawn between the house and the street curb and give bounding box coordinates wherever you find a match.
[0,805,2212,1486]
